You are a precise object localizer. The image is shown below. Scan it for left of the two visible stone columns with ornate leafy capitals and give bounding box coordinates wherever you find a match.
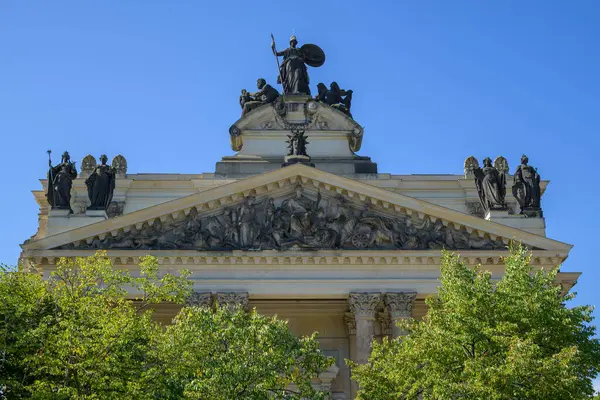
[348,293,381,364]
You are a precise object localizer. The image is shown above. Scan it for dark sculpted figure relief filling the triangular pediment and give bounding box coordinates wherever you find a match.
[55,185,505,251]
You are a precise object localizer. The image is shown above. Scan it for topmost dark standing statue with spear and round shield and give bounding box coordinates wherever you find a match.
[271,35,325,95]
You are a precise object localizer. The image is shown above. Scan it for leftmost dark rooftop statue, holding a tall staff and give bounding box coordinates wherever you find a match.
[46,150,77,213]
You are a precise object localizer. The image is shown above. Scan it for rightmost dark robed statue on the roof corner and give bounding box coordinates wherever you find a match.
[512,154,542,217]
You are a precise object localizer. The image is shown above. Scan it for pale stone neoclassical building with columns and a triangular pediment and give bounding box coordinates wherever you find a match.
[22,91,579,399]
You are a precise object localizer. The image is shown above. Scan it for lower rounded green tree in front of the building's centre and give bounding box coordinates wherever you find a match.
[145,307,333,400]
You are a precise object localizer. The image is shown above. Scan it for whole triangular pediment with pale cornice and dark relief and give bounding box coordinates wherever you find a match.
[23,165,571,254]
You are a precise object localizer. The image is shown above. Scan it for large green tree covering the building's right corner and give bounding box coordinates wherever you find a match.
[353,245,600,400]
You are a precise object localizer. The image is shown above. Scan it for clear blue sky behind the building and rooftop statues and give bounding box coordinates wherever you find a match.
[0,0,600,372]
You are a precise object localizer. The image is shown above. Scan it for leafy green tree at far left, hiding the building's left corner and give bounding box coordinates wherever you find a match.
[0,253,191,399]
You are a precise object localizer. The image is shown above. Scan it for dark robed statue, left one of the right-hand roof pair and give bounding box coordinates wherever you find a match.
[473,157,508,211]
